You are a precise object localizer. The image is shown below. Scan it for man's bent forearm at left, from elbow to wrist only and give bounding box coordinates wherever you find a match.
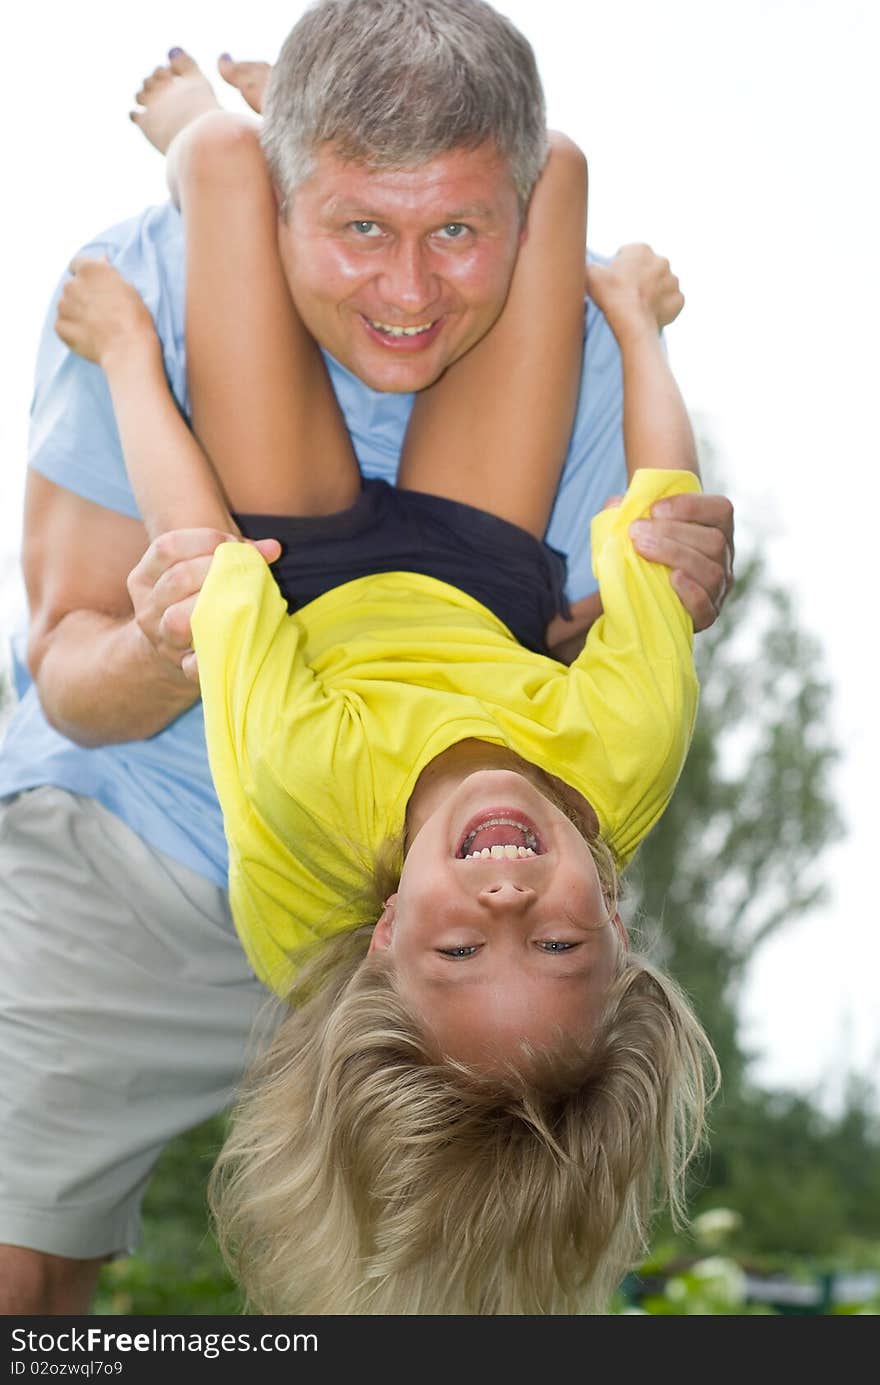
[35,611,198,747]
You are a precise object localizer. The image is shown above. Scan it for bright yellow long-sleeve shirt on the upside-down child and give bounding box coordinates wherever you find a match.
[193,471,698,990]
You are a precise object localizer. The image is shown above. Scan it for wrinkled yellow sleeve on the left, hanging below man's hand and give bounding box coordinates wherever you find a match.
[193,543,346,989]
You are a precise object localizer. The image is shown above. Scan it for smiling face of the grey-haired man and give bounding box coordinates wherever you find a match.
[280,144,522,393]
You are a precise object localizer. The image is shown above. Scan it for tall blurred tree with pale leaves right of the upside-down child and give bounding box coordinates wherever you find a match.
[631,545,841,1094]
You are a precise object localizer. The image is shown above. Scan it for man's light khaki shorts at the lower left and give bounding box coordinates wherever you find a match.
[0,787,269,1259]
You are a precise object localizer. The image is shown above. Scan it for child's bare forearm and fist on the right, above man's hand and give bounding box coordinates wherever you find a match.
[588,245,700,481]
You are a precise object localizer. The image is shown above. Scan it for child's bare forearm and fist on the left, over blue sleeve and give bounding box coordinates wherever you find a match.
[55,259,238,539]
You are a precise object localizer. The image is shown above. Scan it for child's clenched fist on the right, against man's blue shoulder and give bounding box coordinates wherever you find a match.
[586,245,685,338]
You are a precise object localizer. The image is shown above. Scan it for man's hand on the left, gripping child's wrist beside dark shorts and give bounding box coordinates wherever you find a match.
[127,529,281,683]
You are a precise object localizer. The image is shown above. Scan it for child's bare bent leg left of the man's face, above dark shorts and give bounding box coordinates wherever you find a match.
[175,100,360,515]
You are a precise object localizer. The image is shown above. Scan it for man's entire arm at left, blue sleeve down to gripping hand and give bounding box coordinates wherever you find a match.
[22,208,254,747]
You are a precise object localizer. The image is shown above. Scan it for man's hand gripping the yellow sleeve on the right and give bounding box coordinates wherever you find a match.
[629,494,733,630]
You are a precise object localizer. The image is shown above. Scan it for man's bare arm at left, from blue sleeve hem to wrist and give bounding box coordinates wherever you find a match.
[24,471,205,747]
